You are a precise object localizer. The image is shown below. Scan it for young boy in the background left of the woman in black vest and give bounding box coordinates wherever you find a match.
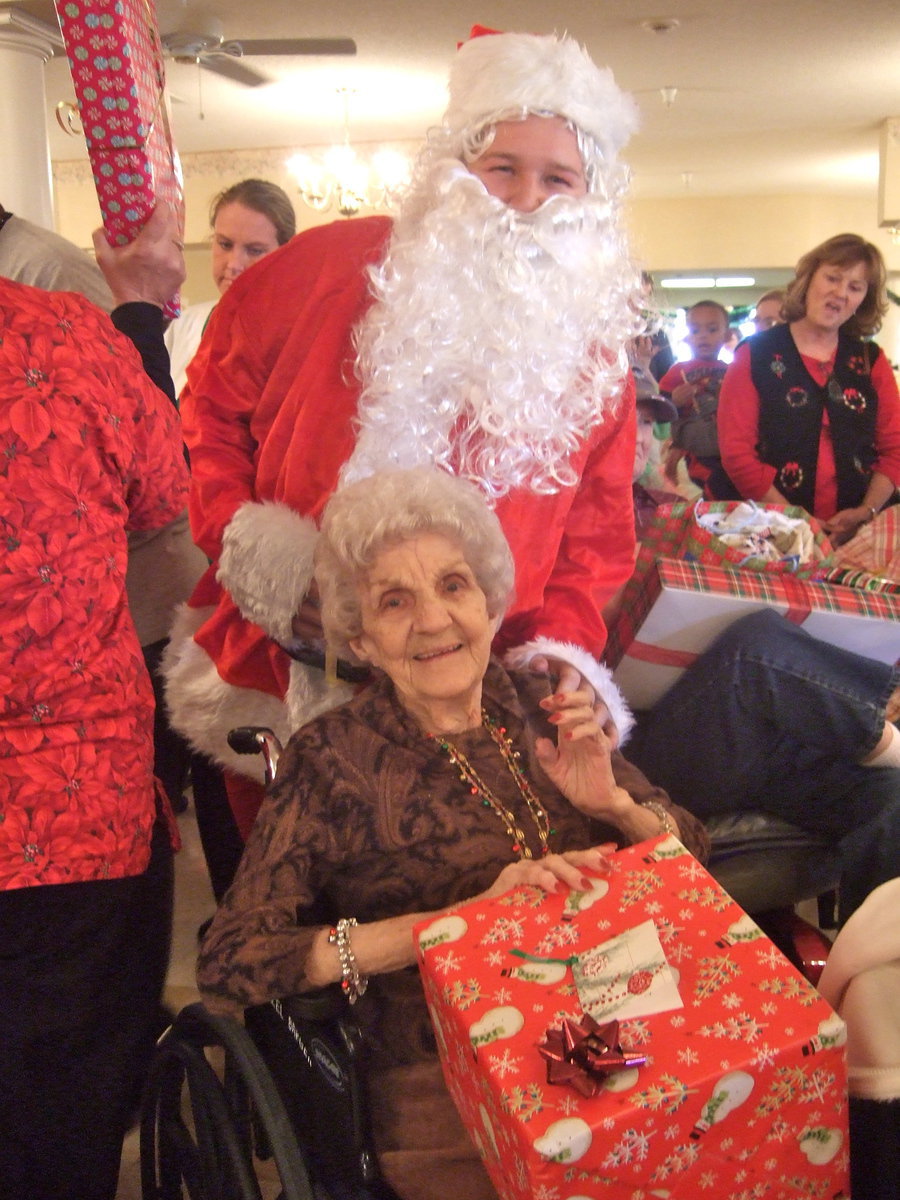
[659,300,740,500]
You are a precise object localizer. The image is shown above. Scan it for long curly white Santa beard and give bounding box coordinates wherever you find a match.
[342,162,638,498]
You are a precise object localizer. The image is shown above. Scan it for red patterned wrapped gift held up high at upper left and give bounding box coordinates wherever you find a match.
[56,0,184,317]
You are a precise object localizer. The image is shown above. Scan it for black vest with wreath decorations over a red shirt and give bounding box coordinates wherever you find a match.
[749,325,881,512]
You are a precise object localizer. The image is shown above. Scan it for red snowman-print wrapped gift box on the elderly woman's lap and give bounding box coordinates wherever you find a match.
[415,838,848,1200]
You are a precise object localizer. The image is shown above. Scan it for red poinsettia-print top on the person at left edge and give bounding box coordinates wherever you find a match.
[0,280,187,889]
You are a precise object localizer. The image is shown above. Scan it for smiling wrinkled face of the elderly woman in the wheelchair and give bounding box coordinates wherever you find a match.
[350,533,497,733]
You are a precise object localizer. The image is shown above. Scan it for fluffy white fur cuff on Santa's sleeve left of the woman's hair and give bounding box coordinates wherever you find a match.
[216,500,319,642]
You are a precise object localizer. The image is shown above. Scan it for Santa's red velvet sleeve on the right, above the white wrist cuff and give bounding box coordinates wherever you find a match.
[532,374,636,658]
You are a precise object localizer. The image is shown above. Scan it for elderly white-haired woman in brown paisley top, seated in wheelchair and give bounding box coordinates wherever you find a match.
[198,469,708,1200]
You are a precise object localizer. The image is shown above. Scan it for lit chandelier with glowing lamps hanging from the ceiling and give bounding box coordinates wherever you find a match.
[287,88,409,217]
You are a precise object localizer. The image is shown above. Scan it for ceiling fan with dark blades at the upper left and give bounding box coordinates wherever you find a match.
[160,17,356,88]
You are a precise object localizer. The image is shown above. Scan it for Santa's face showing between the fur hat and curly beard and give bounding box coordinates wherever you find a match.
[469,115,588,212]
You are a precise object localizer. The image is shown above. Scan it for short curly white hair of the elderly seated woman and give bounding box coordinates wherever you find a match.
[316,467,515,658]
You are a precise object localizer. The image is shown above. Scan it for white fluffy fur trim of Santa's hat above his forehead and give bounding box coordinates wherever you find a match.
[444,34,638,162]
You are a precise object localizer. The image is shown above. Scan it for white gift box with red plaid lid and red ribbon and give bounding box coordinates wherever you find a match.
[605,550,900,712]
